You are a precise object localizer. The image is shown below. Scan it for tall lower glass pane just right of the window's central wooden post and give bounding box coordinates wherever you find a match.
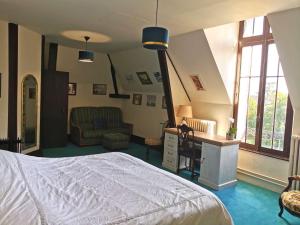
[261,77,277,148]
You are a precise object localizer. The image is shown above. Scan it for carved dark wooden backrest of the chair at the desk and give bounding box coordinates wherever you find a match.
[177,124,195,150]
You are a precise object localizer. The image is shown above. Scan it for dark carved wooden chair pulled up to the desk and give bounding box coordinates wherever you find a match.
[177,124,202,179]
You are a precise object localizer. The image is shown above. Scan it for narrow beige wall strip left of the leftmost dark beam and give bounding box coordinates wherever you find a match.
[0,21,8,138]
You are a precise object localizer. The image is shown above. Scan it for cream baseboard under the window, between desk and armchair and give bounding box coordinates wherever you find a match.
[237,168,287,193]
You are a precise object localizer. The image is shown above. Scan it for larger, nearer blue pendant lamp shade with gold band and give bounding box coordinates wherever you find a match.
[142,27,169,50]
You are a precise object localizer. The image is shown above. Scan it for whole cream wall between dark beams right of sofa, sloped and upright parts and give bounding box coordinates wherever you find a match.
[111,48,167,138]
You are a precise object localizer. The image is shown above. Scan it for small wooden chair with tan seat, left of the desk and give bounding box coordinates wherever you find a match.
[145,121,169,161]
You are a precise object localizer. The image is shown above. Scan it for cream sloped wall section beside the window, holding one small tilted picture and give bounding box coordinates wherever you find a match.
[168,30,231,104]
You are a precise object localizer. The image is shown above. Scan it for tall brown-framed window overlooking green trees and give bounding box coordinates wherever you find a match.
[234,17,293,158]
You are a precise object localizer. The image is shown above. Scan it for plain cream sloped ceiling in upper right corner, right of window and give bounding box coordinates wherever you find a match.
[268,8,300,109]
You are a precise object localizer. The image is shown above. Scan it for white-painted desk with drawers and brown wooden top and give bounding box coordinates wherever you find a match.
[162,128,240,190]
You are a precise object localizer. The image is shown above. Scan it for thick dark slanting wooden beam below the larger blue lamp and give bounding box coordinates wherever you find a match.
[157,51,176,127]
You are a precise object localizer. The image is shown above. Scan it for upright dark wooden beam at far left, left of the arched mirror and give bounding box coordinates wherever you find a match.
[7,23,18,140]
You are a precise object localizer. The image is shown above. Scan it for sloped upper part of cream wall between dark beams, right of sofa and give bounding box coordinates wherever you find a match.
[111,48,163,93]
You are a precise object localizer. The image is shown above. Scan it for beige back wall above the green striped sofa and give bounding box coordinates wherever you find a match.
[57,45,122,132]
